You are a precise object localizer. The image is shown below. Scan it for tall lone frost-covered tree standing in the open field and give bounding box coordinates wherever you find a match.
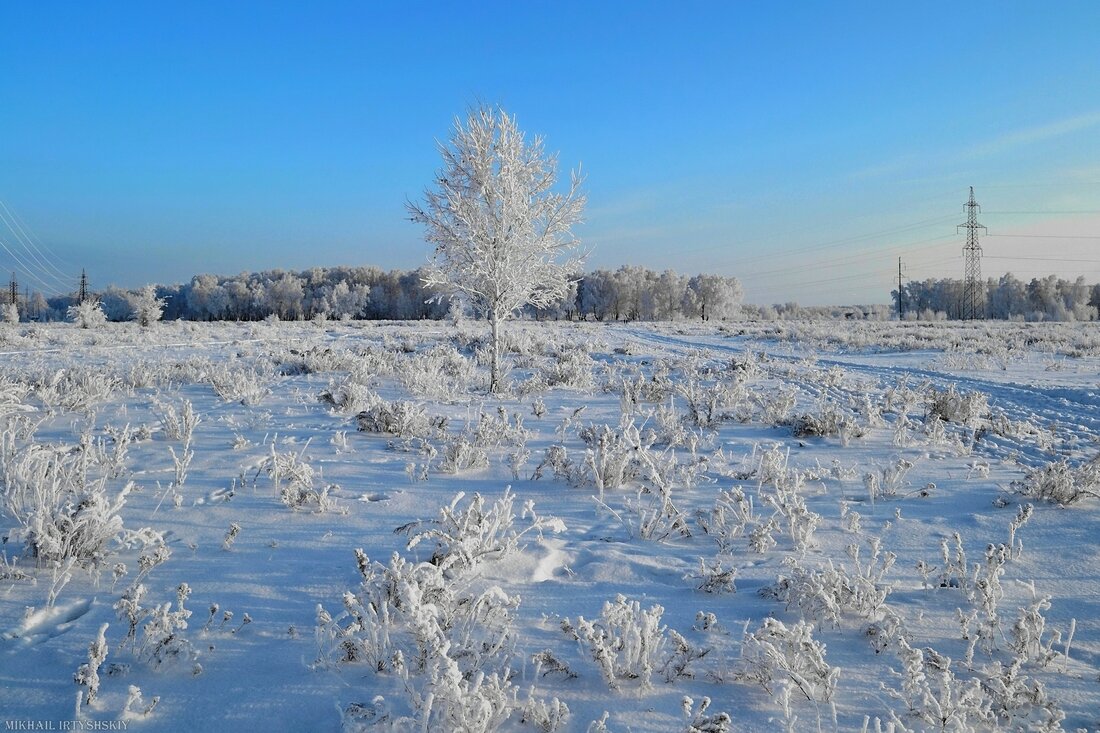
[408,107,585,392]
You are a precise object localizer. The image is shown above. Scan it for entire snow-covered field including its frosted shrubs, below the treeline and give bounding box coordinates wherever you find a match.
[0,321,1100,731]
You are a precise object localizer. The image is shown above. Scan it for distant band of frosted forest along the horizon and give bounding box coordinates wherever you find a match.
[19,266,1100,321]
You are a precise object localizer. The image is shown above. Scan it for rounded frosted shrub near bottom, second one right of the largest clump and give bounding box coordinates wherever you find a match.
[737,619,840,702]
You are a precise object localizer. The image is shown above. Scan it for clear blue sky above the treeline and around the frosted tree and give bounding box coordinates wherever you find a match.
[0,2,1100,305]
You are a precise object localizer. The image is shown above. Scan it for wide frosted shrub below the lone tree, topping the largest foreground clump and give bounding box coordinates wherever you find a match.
[405,486,565,570]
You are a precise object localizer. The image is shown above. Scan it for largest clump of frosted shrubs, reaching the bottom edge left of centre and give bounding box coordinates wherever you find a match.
[317,494,568,732]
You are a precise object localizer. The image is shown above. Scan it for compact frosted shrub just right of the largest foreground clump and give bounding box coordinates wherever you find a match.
[562,594,666,690]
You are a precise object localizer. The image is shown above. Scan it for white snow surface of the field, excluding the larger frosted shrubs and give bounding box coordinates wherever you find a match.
[0,321,1100,732]
